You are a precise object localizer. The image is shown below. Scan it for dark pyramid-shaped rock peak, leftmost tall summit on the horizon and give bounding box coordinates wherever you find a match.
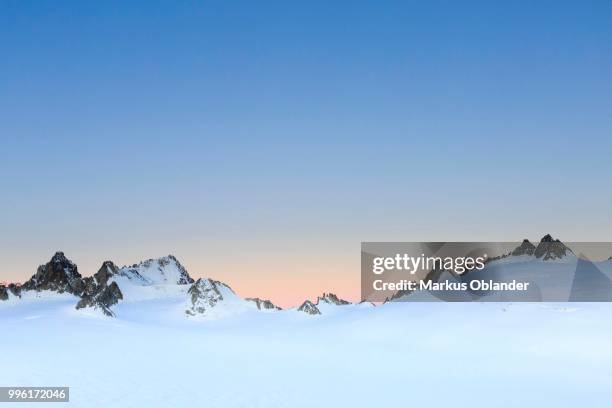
[22,252,85,296]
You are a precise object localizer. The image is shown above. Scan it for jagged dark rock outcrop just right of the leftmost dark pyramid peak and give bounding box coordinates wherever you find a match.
[76,261,123,317]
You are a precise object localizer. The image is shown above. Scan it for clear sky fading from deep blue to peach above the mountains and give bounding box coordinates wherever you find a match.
[0,0,612,306]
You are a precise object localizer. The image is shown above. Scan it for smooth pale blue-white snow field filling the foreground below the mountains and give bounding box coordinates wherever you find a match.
[0,300,612,408]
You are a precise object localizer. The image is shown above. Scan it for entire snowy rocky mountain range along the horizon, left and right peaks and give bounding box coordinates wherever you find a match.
[0,235,612,317]
